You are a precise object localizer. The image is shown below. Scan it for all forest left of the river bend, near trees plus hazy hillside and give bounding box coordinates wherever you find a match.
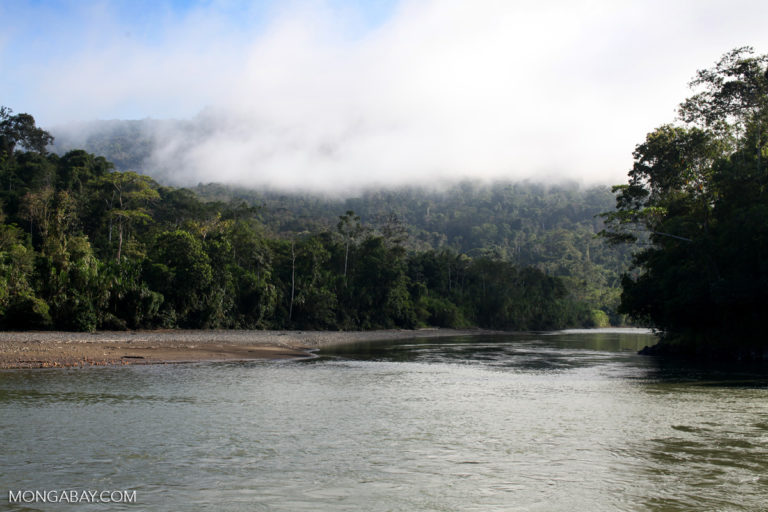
[0,108,627,330]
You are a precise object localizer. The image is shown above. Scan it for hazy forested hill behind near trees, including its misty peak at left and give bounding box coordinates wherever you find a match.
[52,117,633,323]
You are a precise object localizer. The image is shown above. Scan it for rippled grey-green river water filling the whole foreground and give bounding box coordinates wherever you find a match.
[0,331,768,511]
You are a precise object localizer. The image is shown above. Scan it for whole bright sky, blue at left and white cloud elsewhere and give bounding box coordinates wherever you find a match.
[0,0,768,190]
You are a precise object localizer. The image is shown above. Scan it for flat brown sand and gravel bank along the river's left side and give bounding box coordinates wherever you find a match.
[0,329,492,368]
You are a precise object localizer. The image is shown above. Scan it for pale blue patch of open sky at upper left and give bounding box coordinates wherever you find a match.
[0,0,396,123]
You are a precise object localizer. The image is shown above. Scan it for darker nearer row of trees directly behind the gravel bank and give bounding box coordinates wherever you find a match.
[0,108,607,331]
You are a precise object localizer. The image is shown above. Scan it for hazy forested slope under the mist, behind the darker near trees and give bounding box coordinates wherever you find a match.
[194,181,634,324]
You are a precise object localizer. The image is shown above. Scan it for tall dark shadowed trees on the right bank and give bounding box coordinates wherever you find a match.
[605,48,768,357]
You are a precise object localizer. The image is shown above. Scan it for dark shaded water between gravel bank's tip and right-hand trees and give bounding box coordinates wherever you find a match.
[316,329,768,388]
